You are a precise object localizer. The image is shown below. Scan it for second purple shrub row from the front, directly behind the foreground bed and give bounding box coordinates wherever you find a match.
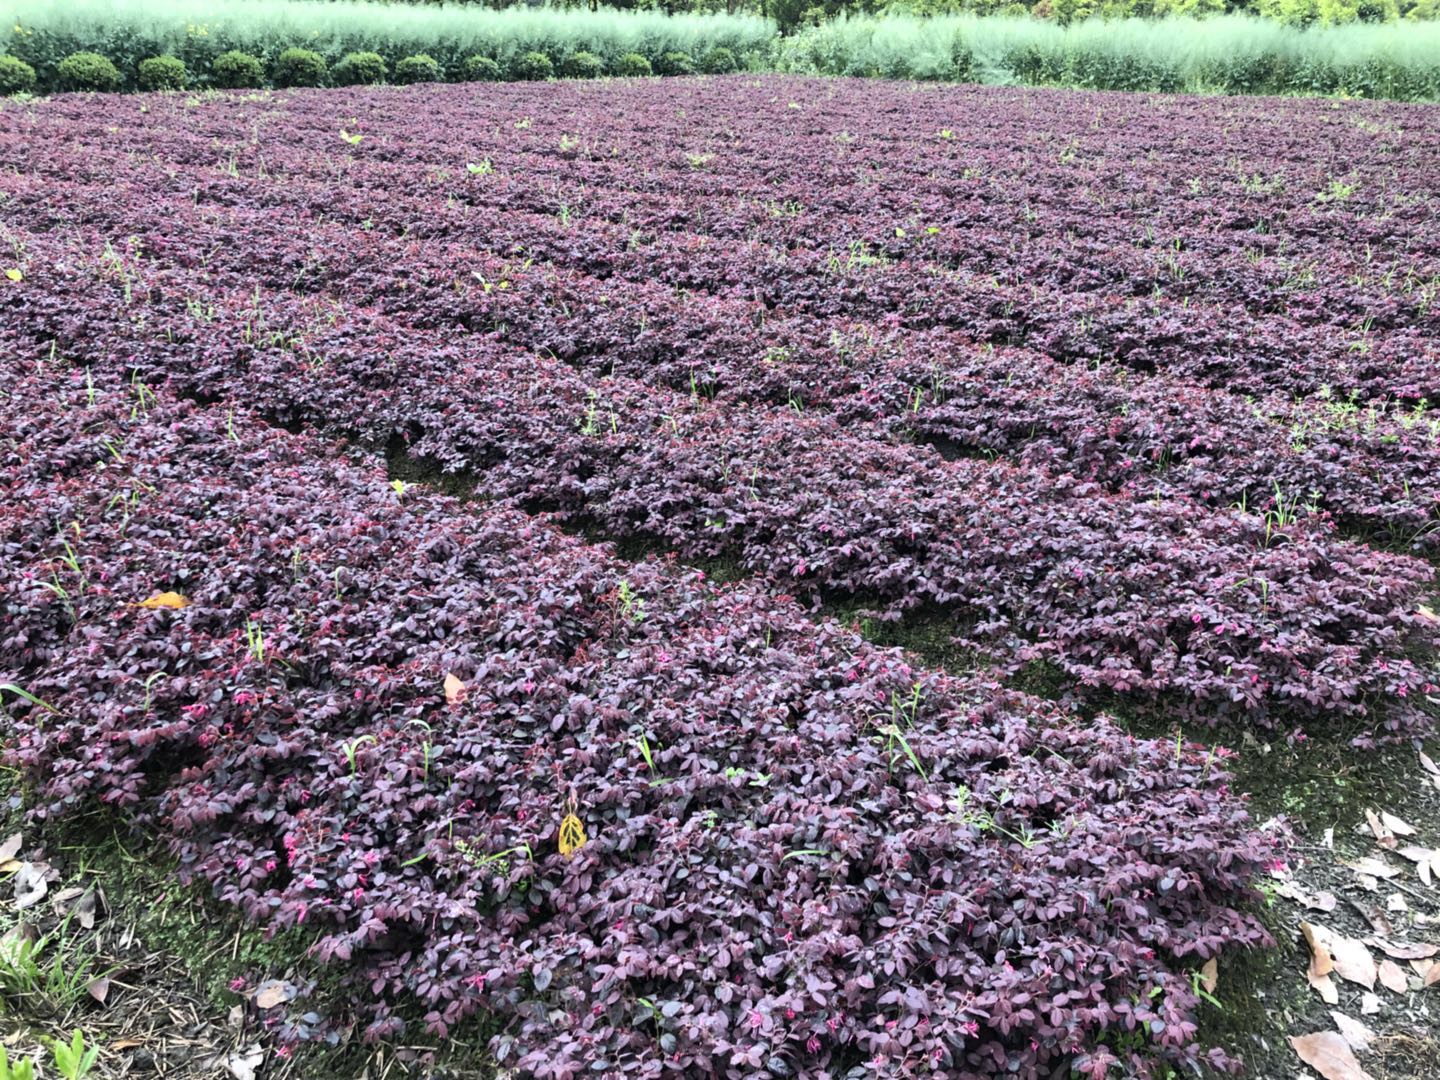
[7,250,1436,742]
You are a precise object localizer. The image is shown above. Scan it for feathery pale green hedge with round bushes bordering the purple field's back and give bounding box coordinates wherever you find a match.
[0,0,1440,99]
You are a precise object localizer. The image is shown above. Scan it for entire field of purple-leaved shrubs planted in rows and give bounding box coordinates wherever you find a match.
[0,69,1440,1080]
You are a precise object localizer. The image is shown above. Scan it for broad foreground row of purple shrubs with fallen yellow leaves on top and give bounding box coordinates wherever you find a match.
[0,364,1274,1079]
